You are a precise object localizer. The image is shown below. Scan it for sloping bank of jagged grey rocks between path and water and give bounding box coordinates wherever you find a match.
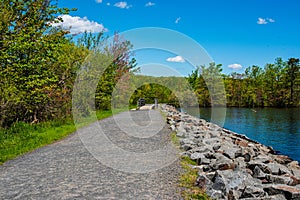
[162,105,300,200]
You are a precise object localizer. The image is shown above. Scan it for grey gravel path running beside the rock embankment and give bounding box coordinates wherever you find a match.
[0,110,182,199]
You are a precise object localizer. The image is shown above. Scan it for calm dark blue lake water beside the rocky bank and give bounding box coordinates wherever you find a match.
[182,108,300,161]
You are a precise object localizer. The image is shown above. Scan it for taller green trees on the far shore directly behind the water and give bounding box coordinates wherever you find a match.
[187,58,300,107]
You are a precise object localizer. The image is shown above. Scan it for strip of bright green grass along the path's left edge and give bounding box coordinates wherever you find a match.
[0,109,128,164]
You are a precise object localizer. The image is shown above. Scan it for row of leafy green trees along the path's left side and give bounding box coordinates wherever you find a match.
[0,0,135,127]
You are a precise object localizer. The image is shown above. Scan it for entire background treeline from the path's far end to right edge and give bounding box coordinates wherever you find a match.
[131,58,300,107]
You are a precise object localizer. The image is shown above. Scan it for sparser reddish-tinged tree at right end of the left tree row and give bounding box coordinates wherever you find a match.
[73,33,136,114]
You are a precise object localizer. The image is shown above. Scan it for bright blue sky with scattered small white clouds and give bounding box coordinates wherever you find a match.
[58,0,300,75]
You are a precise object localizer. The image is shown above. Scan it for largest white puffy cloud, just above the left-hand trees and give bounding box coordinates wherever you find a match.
[52,15,107,34]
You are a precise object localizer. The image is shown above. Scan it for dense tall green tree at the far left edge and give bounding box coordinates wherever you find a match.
[0,0,81,126]
